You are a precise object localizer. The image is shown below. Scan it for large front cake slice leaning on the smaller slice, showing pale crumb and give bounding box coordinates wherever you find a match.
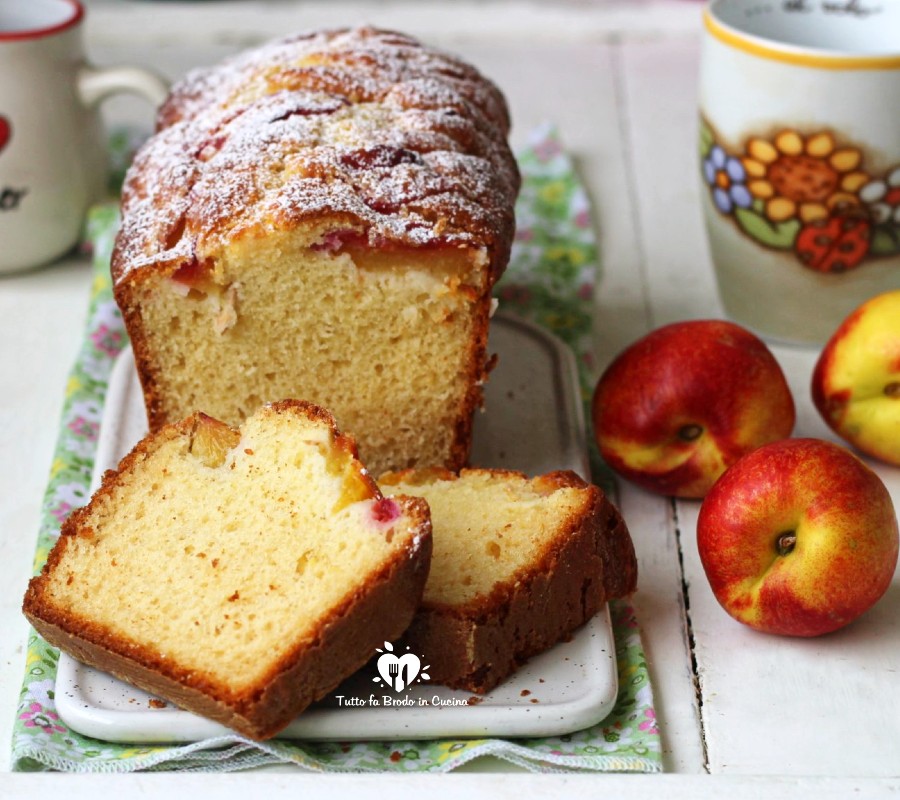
[24,401,431,739]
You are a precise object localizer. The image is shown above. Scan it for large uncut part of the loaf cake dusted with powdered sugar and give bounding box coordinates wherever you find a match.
[112,28,519,474]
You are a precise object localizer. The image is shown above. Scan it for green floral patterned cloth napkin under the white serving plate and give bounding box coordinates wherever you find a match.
[12,128,661,772]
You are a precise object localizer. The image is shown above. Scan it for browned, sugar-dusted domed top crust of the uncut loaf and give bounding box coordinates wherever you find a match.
[113,28,519,288]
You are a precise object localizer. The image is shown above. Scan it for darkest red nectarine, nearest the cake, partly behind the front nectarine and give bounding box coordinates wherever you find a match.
[592,320,795,497]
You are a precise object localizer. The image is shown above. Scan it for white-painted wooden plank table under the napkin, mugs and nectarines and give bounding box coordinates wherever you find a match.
[0,0,900,800]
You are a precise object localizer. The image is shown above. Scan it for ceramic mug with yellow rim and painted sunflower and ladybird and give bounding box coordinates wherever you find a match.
[700,0,900,344]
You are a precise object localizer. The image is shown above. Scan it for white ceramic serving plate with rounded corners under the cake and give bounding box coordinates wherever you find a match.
[56,315,618,743]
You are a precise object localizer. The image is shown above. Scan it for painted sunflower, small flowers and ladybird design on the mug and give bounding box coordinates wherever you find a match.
[700,120,900,274]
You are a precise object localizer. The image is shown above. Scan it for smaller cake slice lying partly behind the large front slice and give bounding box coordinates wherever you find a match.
[379,469,637,693]
